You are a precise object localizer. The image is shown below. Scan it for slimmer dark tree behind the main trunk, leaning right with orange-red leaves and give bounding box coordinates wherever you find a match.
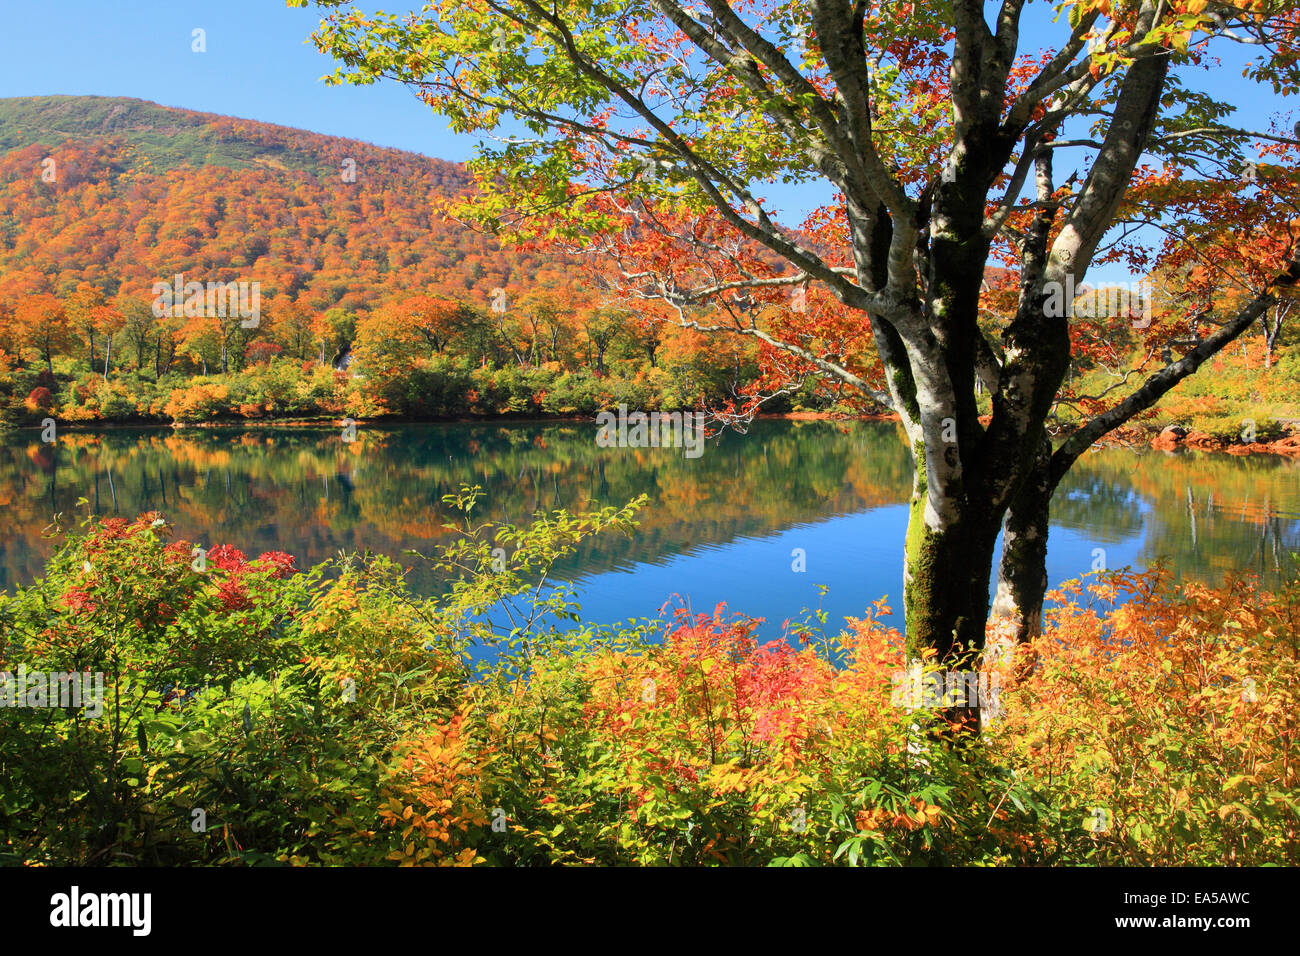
[992,134,1300,640]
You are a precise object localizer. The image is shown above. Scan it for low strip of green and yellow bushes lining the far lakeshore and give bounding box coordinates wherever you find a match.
[0,323,850,427]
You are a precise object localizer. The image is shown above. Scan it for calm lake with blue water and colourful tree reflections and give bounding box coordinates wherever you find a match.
[0,420,1300,637]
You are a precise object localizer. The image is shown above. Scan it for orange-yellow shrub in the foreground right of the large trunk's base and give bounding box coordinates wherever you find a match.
[996,570,1300,866]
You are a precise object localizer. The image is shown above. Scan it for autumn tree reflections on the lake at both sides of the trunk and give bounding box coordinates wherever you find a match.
[0,421,1300,588]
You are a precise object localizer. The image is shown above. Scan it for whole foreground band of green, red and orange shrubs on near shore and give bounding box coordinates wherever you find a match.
[0,489,1300,865]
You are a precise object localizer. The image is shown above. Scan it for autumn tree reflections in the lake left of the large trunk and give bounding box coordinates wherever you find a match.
[0,421,911,587]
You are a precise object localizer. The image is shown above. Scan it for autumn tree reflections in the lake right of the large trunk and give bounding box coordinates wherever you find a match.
[1052,449,1300,587]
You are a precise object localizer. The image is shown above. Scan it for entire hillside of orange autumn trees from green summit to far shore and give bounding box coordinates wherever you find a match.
[0,96,800,424]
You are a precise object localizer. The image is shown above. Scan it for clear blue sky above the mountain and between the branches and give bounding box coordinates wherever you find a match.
[0,0,1294,278]
